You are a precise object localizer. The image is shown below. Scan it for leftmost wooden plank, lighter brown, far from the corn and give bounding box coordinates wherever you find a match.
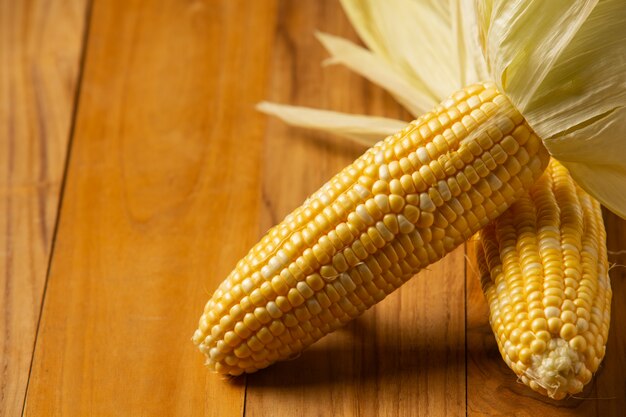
[0,0,87,416]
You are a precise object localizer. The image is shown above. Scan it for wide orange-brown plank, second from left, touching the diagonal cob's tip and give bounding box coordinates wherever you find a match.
[26,0,275,416]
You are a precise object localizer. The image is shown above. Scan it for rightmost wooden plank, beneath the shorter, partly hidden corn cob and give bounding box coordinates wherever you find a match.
[466,213,626,417]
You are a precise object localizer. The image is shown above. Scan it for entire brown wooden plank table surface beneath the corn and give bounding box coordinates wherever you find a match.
[0,0,626,417]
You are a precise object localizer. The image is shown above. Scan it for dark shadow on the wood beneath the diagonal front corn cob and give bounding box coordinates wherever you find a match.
[249,311,464,389]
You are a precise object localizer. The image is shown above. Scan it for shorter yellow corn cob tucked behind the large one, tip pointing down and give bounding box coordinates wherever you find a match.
[476,160,611,399]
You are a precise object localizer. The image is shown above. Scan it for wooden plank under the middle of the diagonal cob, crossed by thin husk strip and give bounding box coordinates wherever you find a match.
[246,0,465,417]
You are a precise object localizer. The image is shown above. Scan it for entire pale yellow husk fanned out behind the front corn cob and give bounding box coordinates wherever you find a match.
[262,0,626,218]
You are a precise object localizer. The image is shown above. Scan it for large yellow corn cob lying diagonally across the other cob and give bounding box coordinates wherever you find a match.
[193,83,549,375]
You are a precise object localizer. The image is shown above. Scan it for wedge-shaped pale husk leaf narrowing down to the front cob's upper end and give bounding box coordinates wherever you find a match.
[476,0,598,110]
